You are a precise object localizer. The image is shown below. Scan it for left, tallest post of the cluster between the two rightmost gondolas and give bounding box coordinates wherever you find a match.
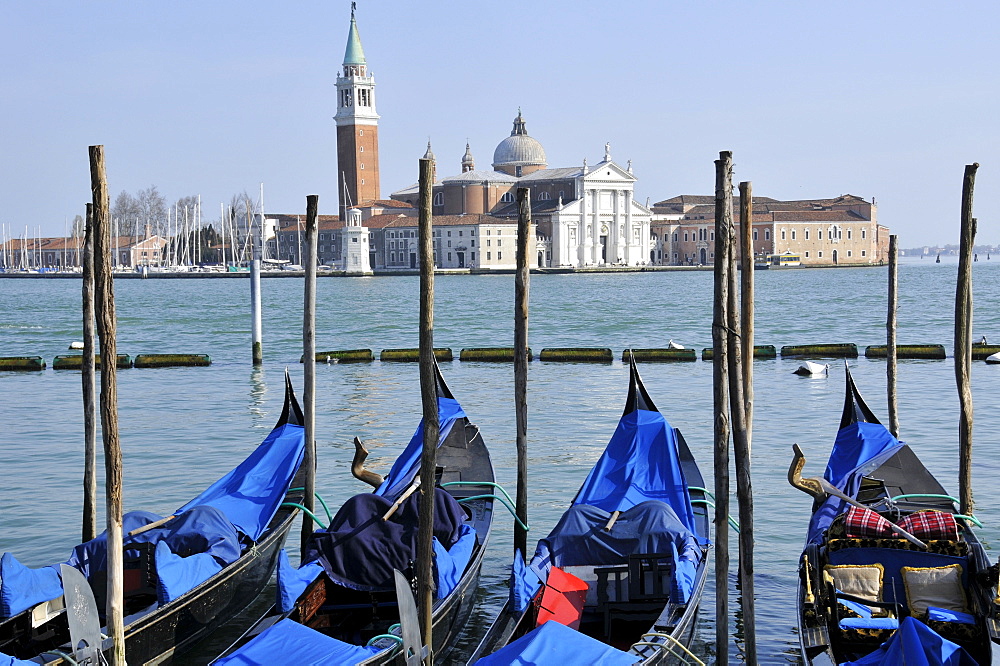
[712,151,733,666]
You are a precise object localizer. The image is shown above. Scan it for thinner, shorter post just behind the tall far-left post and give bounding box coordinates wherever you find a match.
[80,203,97,541]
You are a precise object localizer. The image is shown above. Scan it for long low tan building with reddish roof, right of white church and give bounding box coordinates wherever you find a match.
[651,194,889,266]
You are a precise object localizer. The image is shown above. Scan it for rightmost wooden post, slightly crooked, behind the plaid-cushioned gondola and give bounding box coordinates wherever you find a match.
[955,162,979,516]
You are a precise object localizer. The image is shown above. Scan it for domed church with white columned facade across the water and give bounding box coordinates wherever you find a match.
[390,116,652,267]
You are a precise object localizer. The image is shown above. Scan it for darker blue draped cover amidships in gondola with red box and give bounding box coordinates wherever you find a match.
[531,500,701,603]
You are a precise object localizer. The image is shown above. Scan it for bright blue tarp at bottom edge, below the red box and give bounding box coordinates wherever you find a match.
[476,620,640,666]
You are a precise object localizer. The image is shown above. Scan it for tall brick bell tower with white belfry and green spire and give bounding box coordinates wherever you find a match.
[334,2,380,221]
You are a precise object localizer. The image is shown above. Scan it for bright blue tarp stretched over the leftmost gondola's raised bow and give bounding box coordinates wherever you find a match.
[174,423,305,541]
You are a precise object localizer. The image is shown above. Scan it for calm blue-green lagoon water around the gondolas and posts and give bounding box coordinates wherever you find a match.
[0,259,1000,663]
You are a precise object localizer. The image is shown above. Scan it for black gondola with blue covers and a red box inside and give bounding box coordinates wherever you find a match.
[469,359,710,666]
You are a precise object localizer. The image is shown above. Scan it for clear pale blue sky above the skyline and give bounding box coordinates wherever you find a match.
[0,0,1000,247]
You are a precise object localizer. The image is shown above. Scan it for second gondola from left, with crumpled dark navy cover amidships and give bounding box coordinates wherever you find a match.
[213,366,496,666]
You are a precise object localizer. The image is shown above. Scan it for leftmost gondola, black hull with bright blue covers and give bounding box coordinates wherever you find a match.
[0,372,305,665]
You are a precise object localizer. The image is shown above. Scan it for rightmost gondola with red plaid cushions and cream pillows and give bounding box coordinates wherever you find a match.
[788,369,1000,665]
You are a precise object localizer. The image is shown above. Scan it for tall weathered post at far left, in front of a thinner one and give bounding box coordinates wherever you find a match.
[90,146,125,666]
